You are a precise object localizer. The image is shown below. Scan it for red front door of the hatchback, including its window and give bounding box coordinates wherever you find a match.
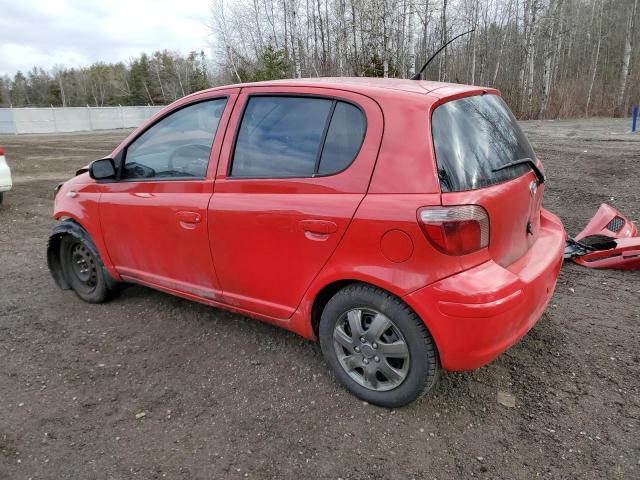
[100,89,238,299]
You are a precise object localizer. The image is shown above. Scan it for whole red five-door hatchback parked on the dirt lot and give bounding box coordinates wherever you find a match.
[48,78,565,407]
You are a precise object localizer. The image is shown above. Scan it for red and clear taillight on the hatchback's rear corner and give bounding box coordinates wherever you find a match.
[418,205,489,255]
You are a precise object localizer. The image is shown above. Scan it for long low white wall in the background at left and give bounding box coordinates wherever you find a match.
[0,107,163,134]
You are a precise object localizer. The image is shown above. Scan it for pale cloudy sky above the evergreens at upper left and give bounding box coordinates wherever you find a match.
[0,0,211,75]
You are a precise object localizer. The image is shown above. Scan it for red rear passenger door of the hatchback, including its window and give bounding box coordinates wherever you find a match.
[209,87,382,319]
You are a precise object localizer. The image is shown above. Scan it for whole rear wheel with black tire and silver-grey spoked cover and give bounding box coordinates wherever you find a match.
[319,284,439,408]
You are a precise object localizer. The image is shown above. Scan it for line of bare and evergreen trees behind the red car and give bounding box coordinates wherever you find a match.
[0,0,640,118]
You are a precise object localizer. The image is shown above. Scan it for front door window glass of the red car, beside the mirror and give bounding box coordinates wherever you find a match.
[120,98,227,180]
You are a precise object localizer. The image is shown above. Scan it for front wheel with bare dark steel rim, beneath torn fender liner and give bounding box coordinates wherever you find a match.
[60,230,118,303]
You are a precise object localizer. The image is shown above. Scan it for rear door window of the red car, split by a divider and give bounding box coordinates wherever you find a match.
[230,96,365,178]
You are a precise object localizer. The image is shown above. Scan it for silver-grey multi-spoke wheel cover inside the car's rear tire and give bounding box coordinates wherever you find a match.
[333,308,411,392]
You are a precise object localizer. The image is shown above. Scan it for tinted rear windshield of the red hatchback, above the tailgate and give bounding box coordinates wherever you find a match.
[432,95,535,192]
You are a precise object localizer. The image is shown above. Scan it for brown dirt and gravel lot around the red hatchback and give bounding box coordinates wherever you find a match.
[0,119,640,479]
